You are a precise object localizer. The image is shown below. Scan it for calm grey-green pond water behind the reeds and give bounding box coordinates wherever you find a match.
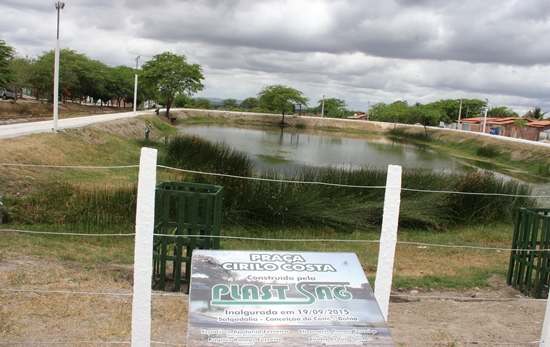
[180,125,486,172]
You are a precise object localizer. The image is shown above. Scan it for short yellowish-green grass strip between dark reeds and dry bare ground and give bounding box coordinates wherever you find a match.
[0,224,513,289]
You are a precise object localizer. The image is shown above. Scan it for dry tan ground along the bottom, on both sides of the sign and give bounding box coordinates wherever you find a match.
[0,252,546,347]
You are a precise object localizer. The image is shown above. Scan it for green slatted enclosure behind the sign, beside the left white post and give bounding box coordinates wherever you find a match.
[153,182,223,293]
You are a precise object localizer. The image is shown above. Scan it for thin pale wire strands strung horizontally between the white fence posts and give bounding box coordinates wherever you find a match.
[0,163,550,346]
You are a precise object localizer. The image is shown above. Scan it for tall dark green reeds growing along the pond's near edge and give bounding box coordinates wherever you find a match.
[163,136,534,231]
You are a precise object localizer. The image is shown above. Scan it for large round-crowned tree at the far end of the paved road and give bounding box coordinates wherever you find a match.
[142,52,204,117]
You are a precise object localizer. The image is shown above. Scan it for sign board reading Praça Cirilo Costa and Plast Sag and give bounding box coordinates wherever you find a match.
[187,250,394,347]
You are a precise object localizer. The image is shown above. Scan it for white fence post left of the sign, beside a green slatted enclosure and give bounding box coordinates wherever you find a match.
[132,147,157,347]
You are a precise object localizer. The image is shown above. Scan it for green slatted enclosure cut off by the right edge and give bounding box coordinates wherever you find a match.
[508,208,550,299]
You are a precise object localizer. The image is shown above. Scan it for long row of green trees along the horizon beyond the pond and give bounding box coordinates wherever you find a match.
[0,40,545,126]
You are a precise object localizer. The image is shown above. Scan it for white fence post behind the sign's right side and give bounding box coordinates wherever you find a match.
[374,165,402,322]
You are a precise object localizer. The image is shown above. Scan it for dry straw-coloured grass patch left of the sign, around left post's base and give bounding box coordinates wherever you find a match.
[0,252,192,346]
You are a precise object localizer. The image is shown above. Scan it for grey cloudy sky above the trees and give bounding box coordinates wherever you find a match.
[0,0,550,115]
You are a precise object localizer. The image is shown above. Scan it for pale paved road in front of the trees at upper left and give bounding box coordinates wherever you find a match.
[0,110,155,139]
